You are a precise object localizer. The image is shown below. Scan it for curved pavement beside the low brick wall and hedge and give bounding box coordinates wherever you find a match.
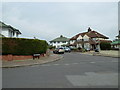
[1,54,63,68]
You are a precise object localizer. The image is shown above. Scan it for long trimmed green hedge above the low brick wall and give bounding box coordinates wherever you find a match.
[2,38,48,55]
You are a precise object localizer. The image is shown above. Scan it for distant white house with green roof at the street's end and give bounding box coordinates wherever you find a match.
[50,35,69,48]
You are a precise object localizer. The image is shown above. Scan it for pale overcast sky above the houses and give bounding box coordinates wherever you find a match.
[0,2,118,41]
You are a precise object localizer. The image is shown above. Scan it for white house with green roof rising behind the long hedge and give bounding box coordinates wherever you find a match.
[0,21,21,38]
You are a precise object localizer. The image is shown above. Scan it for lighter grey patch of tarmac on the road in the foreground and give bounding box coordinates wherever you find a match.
[66,72,118,87]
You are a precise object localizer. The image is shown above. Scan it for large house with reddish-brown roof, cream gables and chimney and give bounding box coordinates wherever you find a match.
[69,27,111,50]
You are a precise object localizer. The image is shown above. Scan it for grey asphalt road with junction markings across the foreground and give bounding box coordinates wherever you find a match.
[3,52,118,88]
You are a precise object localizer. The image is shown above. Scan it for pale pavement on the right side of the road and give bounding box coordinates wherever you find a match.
[82,50,120,58]
